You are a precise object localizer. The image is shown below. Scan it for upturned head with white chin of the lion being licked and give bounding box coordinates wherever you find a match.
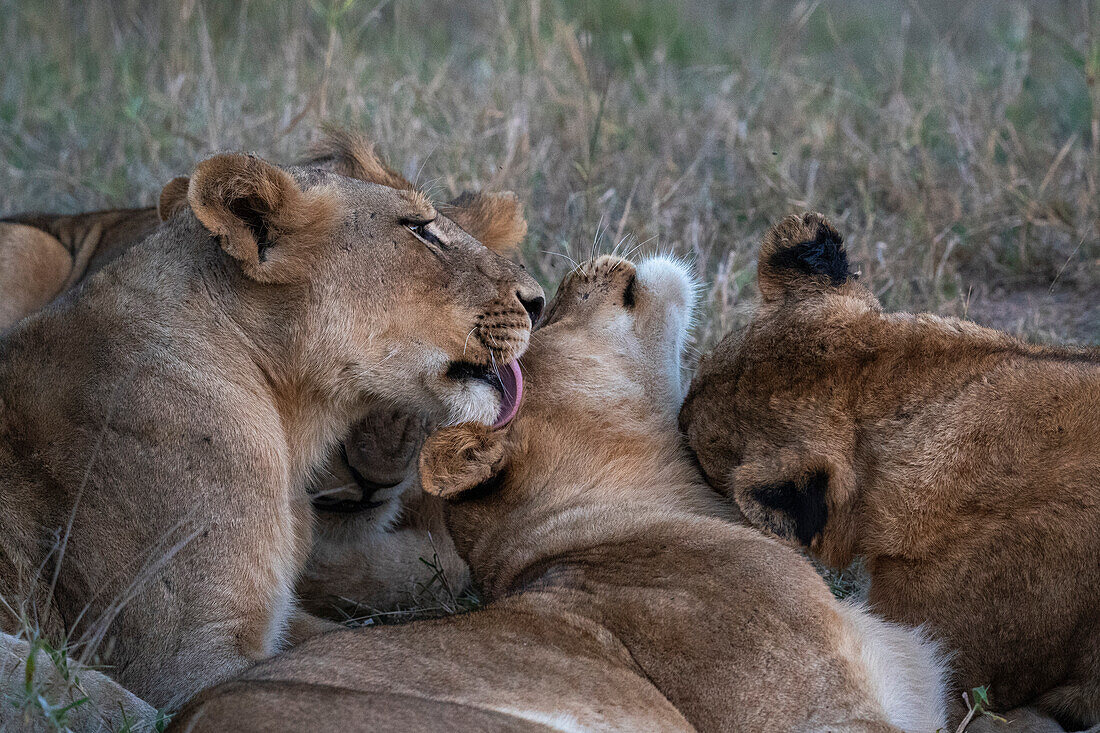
[420,256,695,589]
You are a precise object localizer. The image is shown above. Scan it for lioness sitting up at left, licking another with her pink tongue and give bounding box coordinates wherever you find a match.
[0,154,542,707]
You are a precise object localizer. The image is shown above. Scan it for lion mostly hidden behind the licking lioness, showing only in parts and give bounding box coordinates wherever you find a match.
[0,128,527,620]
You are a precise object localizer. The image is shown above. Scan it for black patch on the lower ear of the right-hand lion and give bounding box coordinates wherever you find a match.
[741,471,828,547]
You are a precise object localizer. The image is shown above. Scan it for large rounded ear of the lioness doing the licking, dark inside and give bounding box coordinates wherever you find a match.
[187,153,336,283]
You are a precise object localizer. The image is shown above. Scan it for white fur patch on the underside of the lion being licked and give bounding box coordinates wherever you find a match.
[839,600,947,733]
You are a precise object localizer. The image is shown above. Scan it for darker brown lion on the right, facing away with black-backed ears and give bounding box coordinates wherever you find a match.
[680,214,1100,726]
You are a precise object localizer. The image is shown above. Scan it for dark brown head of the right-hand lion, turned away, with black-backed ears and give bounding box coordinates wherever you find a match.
[680,214,879,565]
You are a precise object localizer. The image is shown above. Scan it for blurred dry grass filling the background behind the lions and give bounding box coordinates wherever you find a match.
[0,0,1100,347]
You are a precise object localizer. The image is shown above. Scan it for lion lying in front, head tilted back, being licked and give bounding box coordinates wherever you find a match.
[173,258,942,732]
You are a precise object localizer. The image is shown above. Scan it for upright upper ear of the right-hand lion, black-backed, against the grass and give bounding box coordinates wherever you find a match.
[757,212,854,300]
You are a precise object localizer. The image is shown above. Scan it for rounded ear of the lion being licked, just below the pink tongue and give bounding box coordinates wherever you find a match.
[420,423,505,499]
